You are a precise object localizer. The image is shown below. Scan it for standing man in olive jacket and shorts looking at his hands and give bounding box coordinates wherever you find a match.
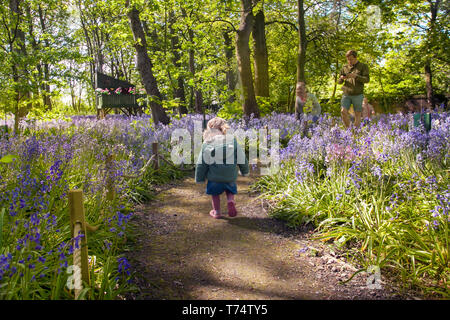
[338,50,370,128]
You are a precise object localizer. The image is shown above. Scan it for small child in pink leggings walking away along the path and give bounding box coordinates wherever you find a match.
[195,117,249,219]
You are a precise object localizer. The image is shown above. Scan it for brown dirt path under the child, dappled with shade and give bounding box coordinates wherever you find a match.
[127,171,418,300]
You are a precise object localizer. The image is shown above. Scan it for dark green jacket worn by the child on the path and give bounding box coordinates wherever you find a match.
[195,136,250,182]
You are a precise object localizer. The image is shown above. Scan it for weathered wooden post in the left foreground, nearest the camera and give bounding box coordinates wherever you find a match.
[69,189,90,299]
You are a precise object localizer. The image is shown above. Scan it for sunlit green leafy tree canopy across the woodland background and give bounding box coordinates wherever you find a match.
[0,0,450,119]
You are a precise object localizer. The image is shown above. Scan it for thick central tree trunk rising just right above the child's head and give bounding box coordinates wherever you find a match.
[236,0,259,117]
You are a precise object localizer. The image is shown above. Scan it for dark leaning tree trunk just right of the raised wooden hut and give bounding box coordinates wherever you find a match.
[126,1,169,124]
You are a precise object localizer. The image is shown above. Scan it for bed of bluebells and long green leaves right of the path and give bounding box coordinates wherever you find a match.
[252,116,450,298]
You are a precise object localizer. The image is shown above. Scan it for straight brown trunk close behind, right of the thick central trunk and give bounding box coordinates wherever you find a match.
[252,10,269,97]
